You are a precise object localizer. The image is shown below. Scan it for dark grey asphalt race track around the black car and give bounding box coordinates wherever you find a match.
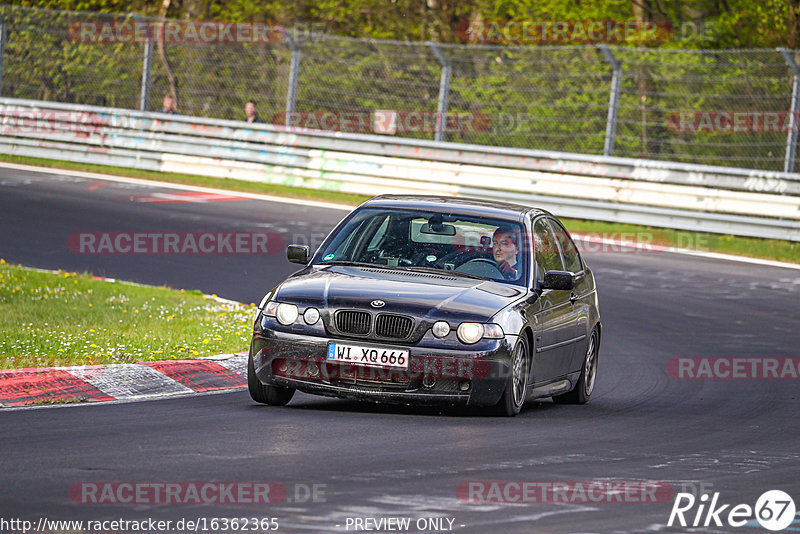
[0,165,800,533]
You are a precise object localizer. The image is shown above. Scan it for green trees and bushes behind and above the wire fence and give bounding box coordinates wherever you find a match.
[0,0,792,170]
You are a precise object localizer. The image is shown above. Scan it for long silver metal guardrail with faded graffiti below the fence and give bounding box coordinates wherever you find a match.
[0,98,800,241]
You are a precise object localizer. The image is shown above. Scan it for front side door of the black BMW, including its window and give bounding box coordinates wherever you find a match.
[532,217,576,385]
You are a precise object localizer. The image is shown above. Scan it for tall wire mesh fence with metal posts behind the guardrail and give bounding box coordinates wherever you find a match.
[0,5,800,172]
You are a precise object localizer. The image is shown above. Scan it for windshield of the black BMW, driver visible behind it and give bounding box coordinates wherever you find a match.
[316,208,527,285]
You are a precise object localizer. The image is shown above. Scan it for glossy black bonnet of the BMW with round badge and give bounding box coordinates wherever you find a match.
[273,266,522,321]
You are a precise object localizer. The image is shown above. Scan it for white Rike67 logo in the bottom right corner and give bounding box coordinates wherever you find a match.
[667,490,796,531]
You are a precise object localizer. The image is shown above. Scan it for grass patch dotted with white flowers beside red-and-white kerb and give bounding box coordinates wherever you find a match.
[0,260,253,369]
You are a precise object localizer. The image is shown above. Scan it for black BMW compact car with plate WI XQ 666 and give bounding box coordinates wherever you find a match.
[248,195,602,416]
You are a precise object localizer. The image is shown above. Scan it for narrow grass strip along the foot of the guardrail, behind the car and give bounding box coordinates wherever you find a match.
[0,154,800,263]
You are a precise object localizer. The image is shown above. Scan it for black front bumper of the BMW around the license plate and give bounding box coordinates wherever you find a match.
[250,329,516,406]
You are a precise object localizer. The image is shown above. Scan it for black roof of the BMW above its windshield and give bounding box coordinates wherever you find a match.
[361,195,550,220]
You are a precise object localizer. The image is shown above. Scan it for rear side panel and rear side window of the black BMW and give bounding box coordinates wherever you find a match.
[548,217,593,372]
